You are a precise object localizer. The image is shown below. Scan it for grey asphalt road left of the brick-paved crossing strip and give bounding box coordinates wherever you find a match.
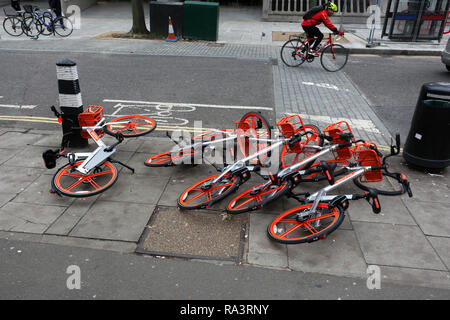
[0,51,275,134]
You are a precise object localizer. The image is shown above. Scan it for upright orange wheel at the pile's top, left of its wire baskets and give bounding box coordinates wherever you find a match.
[237,112,272,161]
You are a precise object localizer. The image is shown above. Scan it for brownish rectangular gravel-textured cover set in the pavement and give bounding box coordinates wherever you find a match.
[136,207,247,263]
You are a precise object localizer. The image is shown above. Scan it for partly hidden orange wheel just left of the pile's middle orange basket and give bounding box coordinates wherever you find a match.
[281,124,324,170]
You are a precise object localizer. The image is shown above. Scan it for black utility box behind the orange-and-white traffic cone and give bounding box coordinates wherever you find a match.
[150,1,183,38]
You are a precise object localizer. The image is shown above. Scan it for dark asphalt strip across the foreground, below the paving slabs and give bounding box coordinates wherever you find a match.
[0,239,448,302]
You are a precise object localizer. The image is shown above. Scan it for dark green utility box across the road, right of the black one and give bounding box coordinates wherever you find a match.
[183,1,219,41]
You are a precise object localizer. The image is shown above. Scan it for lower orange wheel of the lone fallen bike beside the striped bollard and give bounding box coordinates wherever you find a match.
[52,160,118,197]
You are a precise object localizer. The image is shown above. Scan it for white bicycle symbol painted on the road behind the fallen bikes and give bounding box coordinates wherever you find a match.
[107,103,196,126]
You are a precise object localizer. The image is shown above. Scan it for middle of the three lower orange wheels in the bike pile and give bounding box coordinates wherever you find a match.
[227,180,292,214]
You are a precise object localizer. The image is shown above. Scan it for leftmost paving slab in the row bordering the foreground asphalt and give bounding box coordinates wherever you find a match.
[0,202,65,234]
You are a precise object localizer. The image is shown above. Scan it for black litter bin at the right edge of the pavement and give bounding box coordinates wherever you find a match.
[403,82,450,169]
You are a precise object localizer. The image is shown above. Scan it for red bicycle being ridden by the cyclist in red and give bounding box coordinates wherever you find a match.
[281,33,349,72]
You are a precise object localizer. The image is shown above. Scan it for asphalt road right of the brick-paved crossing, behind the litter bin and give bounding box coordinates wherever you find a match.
[344,55,450,142]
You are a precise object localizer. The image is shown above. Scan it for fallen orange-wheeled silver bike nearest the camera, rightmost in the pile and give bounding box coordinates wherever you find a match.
[267,136,412,244]
